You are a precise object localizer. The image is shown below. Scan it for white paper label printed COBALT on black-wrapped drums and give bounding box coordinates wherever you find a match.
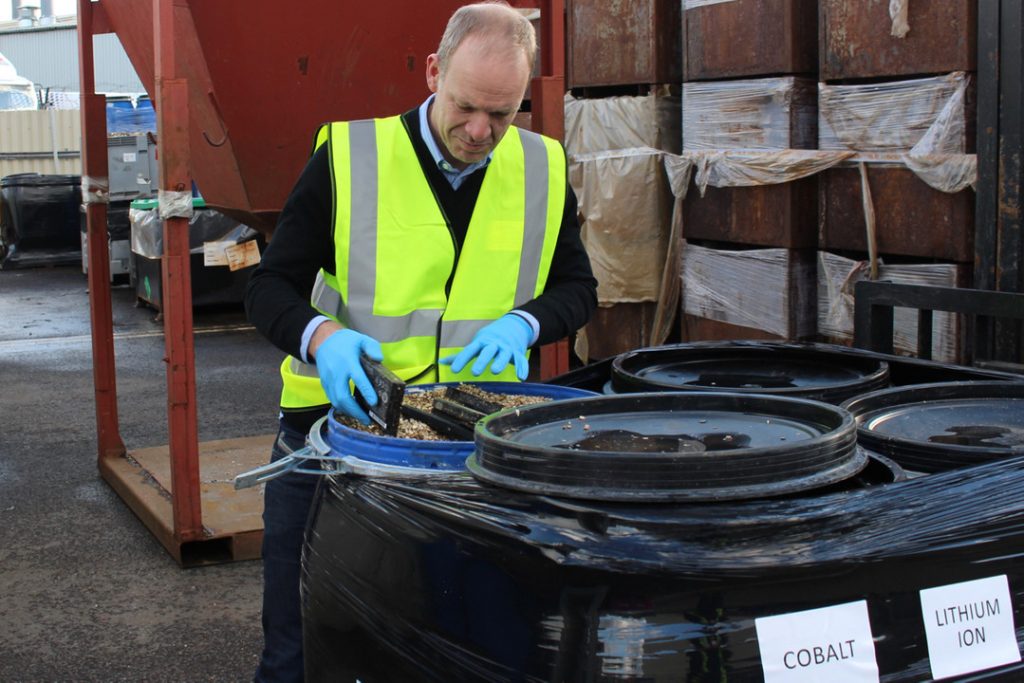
[754,600,879,683]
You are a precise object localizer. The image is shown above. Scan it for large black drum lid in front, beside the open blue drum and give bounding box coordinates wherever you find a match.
[467,392,867,502]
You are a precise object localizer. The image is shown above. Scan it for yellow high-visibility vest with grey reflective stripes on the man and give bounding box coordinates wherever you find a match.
[281,117,566,409]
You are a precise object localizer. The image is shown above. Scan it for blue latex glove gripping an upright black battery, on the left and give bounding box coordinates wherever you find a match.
[315,330,384,425]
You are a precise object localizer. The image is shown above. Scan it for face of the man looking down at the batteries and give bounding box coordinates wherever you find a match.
[427,36,529,168]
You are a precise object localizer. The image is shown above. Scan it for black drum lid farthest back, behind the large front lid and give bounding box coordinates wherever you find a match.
[611,342,889,403]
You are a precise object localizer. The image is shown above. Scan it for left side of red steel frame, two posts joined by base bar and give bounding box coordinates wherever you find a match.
[78,0,204,562]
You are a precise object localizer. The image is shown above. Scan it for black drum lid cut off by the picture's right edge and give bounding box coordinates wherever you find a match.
[843,382,1024,472]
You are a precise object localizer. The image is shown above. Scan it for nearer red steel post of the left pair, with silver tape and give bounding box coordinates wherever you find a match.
[153,0,203,542]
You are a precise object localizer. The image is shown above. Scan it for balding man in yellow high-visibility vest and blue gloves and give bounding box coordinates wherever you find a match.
[246,2,597,681]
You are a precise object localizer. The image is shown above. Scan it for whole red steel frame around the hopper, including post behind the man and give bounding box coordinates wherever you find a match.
[78,0,568,563]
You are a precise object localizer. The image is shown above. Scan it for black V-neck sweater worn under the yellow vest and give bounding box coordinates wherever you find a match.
[245,109,597,428]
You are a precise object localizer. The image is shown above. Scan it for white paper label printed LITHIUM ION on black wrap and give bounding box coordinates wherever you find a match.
[921,575,1021,678]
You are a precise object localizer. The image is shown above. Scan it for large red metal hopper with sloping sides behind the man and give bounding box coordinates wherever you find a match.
[96,0,464,232]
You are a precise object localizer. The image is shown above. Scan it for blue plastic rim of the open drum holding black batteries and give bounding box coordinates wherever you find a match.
[325,382,595,472]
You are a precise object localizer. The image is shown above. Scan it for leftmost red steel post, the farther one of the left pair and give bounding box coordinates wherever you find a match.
[78,0,125,460]
